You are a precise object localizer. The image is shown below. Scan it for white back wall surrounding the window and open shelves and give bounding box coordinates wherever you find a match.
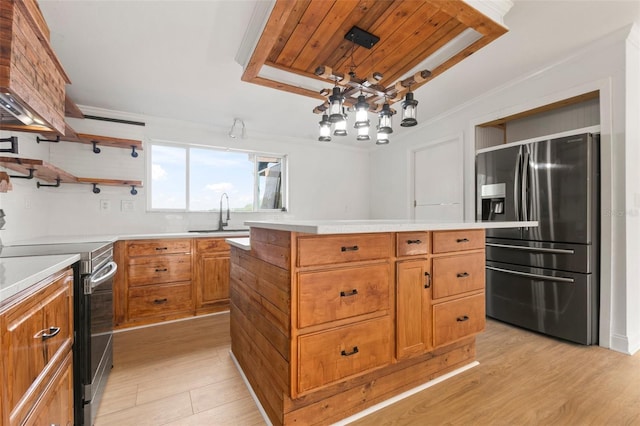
[0,107,369,244]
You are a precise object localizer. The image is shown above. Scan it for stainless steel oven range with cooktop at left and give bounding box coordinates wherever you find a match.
[0,242,118,425]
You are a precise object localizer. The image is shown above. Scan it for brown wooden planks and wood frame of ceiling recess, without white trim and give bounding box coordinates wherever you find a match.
[242,0,507,111]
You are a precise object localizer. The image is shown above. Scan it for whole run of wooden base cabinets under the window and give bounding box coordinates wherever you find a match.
[114,237,235,328]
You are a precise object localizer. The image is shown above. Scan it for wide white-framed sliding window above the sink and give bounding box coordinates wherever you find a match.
[149,142,286,212]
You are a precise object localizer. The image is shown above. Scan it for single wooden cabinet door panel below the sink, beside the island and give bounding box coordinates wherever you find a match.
[198,255,229,307]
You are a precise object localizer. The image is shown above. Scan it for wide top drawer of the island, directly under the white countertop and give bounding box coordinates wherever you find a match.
[298,233,392,266]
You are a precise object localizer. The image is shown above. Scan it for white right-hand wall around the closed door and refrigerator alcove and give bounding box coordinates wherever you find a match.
[370,28,640,352]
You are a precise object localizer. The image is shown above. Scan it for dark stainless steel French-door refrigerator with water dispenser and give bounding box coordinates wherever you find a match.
[476,133,600,345]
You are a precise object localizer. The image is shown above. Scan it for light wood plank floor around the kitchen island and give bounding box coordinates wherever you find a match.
[96,314,640,426]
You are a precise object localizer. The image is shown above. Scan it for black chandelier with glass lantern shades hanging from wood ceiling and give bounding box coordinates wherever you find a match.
[313,27,431,145]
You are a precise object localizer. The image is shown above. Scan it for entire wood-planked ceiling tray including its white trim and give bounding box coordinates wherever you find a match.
[236,0,512,112]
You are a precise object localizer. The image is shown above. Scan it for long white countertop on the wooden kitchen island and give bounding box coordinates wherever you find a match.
[244,220,538,234]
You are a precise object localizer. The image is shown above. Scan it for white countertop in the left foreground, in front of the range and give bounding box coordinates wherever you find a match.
[0,254,80,305]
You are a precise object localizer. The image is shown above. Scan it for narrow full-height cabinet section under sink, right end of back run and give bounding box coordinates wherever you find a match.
[195,238,230,313]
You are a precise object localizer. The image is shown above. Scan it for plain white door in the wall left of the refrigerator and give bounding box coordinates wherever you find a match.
[413,137,464,222]
